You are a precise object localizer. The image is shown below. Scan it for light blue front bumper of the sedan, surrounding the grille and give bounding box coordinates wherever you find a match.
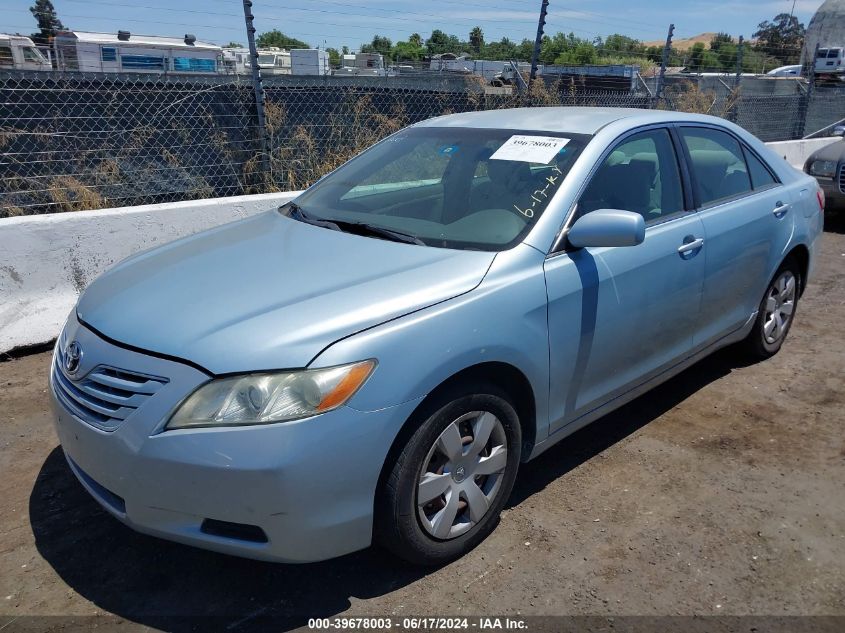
[51,317,418,562]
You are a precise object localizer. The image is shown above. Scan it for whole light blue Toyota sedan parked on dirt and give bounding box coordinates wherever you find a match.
[51,108,823,564]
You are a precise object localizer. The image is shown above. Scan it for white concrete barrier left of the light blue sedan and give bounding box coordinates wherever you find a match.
[0,193,296,354]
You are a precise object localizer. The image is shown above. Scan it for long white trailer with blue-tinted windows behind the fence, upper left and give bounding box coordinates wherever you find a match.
[53,31,223,75]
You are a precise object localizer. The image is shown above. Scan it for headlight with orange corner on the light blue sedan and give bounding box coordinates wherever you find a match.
[166,360,376,429]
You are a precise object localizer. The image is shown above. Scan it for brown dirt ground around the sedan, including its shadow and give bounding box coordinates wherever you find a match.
[0,220,845,630]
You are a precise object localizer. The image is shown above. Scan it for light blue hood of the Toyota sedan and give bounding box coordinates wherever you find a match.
[77,211,495,374]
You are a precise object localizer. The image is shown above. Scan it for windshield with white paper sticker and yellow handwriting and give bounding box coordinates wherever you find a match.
[288,127,591,251]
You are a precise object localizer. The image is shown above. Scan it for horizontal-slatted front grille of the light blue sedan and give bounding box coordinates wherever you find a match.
[52,347,168,431]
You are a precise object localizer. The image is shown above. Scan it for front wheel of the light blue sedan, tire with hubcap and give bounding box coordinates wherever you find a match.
[375,384,522,565]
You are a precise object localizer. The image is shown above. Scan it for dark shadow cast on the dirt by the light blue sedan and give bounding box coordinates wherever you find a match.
[29,350,741,631]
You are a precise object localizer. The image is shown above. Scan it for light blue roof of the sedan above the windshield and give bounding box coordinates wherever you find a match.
[415,106,725,134]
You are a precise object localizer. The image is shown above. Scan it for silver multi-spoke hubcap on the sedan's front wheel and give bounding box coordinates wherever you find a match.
[417,411,508,540]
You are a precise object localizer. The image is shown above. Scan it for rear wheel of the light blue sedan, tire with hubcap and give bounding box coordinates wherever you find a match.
[742,257,801,360]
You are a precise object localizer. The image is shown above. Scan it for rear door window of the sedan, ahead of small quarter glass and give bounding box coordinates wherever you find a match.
[680,127,752,206]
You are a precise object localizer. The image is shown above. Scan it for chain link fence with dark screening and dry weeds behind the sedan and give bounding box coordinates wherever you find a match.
[0,71,845,217]
